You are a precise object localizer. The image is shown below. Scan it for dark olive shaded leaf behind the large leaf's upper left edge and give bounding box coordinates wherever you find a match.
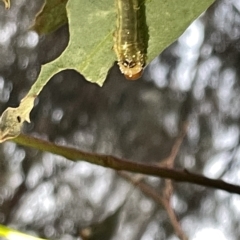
[31,0,68,34]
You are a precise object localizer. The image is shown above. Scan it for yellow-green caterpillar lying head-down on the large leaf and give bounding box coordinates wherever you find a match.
[114,0,146,80]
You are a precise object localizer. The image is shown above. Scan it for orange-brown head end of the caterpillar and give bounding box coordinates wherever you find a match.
[118,60,143,80]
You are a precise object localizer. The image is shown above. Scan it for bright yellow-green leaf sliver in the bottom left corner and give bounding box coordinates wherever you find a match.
[0,225,44,240]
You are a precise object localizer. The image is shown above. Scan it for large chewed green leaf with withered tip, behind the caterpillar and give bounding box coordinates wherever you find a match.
[0,0,214,142]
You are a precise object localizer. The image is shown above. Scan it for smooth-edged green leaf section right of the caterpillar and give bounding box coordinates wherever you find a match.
[146,0,214,62]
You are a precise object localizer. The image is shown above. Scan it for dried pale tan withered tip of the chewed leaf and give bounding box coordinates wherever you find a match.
[0,94,35,143]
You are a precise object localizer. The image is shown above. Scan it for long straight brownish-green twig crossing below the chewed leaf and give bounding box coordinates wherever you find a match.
[12,134,240,195]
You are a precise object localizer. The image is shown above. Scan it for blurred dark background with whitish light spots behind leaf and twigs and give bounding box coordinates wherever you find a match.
[0,0,240,240]
